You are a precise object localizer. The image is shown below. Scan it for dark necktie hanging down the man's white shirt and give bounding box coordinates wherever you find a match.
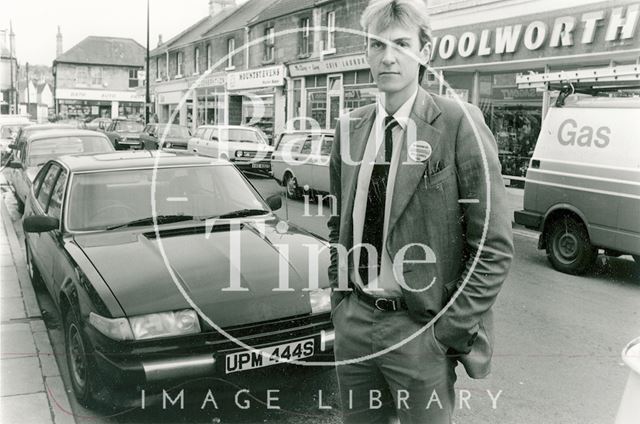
[359,116,398,285]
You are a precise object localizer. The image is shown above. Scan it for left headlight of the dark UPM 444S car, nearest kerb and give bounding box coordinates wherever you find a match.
[129,309,200,340]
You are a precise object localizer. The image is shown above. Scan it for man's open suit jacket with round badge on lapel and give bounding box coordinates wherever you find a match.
[328,88,513,378]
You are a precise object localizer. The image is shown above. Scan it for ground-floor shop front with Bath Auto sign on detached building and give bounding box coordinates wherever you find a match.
[56,88,144,120]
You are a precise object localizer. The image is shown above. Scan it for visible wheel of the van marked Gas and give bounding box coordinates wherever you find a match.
[547,216,598,275]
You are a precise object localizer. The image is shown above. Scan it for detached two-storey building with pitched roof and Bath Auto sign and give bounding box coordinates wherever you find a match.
[53,36,145,119]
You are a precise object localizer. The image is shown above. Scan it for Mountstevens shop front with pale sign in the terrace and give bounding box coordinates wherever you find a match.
[225,65,286,143]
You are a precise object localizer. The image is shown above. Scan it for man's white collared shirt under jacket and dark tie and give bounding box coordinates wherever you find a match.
[351,89,418,297]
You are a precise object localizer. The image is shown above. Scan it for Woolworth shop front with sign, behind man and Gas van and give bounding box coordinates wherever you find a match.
[431,1,640,185]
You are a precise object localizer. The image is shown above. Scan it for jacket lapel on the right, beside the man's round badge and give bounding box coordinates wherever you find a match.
[387,87,441,237]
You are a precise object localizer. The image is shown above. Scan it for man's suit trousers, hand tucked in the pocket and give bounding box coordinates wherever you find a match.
[332,293,456,424]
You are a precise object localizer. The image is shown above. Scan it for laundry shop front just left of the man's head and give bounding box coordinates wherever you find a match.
[287,53,377,129]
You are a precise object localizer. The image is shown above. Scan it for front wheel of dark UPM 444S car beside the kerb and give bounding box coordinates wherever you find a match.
[64,307,97,407]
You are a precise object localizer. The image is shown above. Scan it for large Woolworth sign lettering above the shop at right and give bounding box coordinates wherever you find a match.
[432,2,640,67]
